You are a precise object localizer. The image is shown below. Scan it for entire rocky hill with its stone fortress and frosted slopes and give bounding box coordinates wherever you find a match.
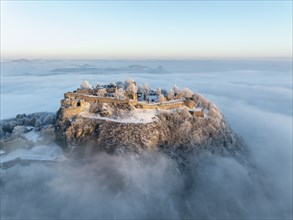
[55,79,244,154]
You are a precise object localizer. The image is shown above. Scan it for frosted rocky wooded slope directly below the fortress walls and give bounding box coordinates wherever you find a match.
[55,95,246,155]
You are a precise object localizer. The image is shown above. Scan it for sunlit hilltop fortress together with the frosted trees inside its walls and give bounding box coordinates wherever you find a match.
[60,79,204,118]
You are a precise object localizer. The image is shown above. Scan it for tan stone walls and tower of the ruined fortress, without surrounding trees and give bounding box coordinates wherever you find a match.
[60,81,204,118]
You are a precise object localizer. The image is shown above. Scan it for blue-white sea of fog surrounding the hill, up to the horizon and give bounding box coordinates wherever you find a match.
[0,59,293,219]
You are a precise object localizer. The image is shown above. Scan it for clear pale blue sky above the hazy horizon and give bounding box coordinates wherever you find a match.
[1,0,292,59]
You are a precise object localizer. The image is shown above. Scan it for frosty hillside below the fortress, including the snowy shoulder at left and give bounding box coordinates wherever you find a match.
[0,94,247,160]
